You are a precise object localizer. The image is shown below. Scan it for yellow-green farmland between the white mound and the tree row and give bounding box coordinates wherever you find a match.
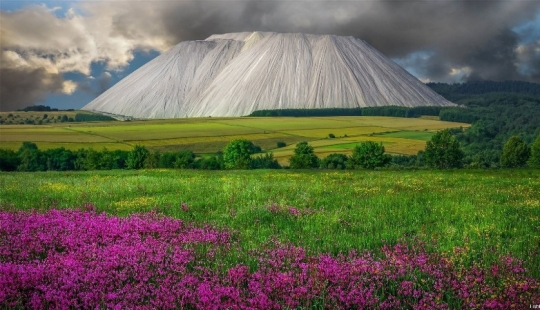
[0,112,469,164]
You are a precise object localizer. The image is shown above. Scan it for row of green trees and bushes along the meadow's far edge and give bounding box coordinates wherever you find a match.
[0,129,540,171]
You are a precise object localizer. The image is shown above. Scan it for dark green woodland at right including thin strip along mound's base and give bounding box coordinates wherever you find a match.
[252,81,540,167]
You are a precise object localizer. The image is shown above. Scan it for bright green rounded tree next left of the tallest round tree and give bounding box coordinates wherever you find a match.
[348,141,392,169]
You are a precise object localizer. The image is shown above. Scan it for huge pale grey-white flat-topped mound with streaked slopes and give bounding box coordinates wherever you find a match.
[83,32,453,118]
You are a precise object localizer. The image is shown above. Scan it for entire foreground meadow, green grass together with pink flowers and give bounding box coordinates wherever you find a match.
[0,170,540,309]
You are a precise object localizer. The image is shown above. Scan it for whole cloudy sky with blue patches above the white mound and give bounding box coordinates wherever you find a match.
[0,0,540,110]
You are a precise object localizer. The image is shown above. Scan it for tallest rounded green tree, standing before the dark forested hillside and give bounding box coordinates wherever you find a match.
[424,129,464,169]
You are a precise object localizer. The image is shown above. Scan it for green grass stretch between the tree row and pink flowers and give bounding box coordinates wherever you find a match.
[0,170,540,278]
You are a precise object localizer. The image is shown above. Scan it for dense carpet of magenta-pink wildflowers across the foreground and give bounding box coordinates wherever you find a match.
[0,210,540,309]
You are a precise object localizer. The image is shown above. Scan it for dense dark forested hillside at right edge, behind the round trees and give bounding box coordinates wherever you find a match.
[428,81,540,167]
